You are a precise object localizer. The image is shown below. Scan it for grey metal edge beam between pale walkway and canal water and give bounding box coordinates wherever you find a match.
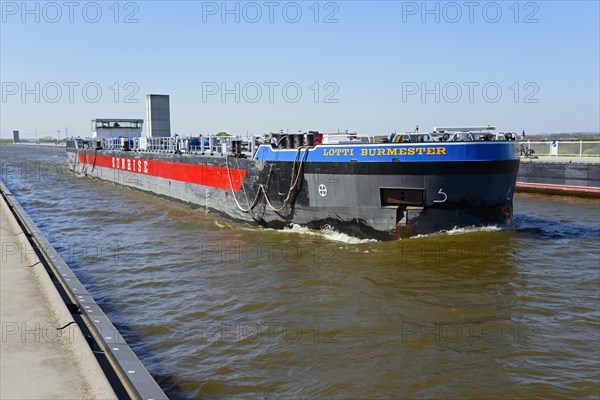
[0,181,167,400]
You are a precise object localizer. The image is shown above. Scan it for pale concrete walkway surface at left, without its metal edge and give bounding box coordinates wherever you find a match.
[0,197,116,400]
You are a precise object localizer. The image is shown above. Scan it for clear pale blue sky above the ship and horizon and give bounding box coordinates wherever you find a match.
[0,1,600,138]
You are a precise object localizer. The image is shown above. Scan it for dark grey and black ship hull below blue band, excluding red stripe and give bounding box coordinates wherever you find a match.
[67,149,519,240]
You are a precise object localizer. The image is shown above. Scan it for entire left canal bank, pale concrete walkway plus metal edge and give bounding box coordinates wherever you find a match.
[0,182,167,400]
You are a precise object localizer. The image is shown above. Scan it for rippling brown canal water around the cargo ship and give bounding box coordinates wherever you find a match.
[0,145,600,399]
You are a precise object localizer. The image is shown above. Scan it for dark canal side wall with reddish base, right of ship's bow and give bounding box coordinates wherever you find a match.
[517,157,600,197]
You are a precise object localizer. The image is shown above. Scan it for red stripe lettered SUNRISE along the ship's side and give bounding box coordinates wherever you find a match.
[78,153,246,192]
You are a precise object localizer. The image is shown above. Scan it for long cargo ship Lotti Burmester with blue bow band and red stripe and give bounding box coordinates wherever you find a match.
[67,119,519,240]
